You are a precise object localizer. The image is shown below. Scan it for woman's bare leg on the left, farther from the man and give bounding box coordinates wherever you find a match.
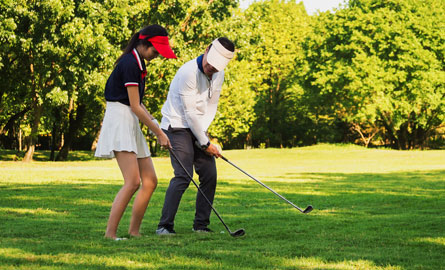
[105,151,141,239]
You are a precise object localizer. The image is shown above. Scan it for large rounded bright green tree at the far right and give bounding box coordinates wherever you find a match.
[302,0,445,149]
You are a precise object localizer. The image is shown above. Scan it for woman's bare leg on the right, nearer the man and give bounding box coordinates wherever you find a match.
[128,157,158,236]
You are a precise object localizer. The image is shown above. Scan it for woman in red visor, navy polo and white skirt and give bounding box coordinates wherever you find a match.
[95,25,176,240]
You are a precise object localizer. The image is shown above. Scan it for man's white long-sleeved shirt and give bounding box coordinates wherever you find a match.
[161,58,224,145]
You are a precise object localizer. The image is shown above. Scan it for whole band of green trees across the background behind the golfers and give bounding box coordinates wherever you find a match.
[0,0,445,160]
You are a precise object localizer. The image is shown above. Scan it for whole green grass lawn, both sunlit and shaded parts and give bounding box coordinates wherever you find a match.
[0,145,445,270]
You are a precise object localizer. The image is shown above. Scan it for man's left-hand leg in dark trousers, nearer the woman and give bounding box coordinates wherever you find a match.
[158,128,194,230]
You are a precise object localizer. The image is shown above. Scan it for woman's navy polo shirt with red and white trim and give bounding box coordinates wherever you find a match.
[105,49,147,106]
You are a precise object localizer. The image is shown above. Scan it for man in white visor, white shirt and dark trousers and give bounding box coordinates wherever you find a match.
[156,37,235,235]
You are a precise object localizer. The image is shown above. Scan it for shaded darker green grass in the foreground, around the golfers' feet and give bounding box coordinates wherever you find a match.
[0,171,445,269]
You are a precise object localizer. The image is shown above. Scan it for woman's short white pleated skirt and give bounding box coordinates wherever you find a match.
[94,101,150,158]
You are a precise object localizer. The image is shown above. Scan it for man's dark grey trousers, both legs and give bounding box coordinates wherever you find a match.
[158,127,217,229]
